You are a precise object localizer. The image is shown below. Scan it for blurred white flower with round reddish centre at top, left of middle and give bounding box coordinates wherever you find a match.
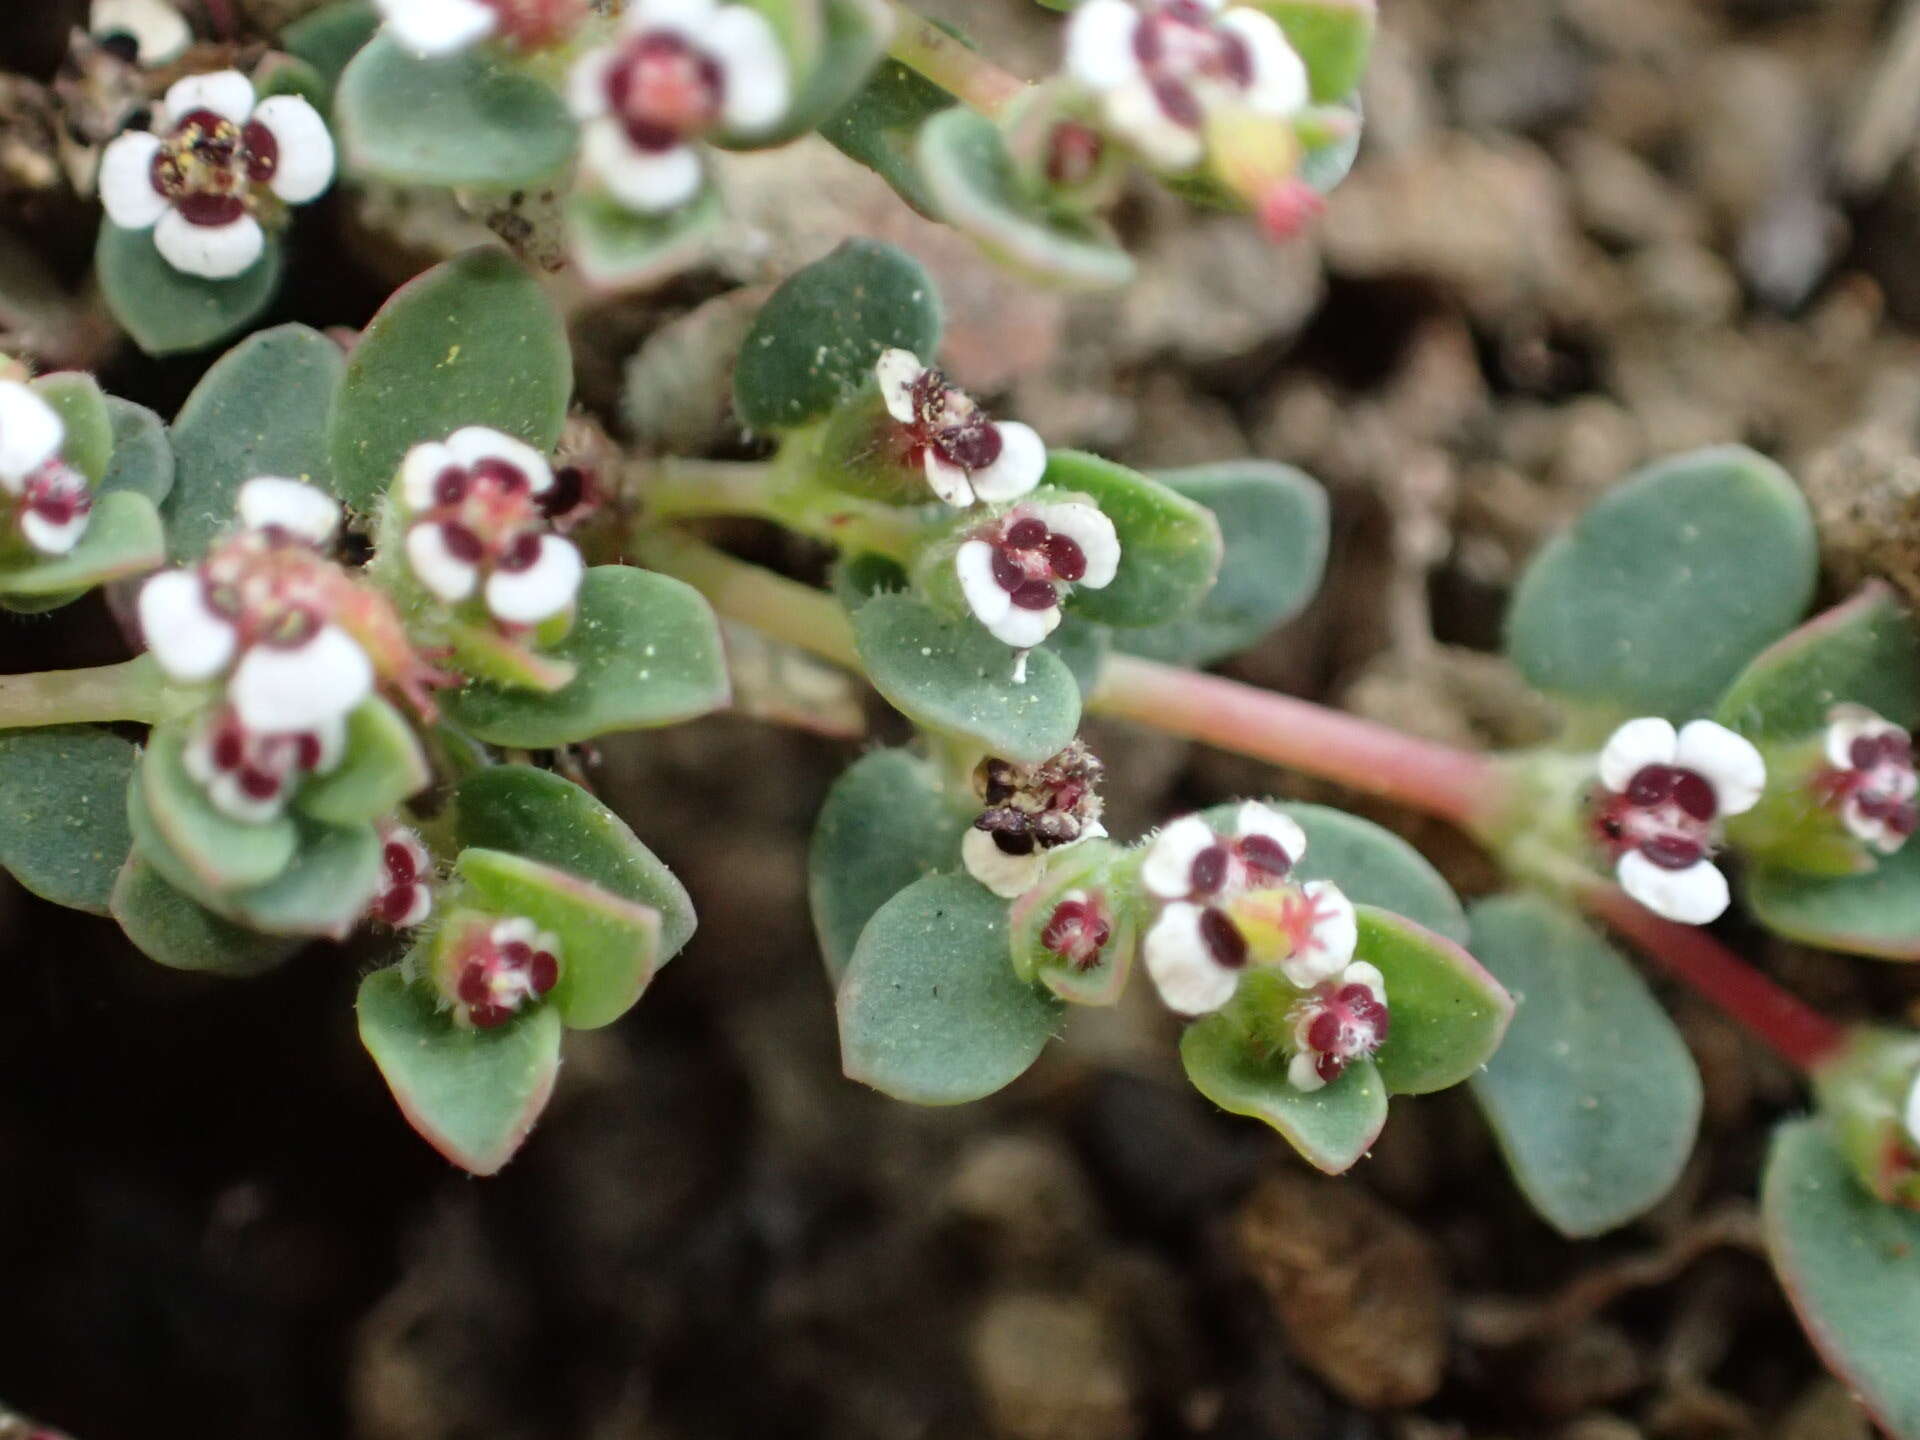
[570,0,791,213]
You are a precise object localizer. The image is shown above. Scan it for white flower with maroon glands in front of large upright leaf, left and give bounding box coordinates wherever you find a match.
[399,426,586,626]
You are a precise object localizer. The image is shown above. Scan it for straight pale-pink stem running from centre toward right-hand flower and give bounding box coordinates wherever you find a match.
[1091,655,1505,831]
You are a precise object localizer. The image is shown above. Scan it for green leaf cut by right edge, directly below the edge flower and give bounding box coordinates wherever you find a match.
[1745,843,1920,960]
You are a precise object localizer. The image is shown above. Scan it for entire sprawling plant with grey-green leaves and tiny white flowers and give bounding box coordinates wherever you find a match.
[0,0,1920,1436]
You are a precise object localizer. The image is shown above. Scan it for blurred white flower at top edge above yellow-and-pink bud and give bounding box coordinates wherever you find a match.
[1066,0,1309,171]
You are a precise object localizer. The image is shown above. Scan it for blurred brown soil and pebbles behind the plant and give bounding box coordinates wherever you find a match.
[0,0,1920,1440]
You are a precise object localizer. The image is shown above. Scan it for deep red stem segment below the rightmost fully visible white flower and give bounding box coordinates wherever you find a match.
[1580,883,1847,1075]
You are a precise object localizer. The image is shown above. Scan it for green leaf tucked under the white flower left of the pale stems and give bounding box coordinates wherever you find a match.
[445,564,730,749]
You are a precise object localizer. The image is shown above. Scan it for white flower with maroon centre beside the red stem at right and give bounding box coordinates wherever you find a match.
[1596,716,1766,925]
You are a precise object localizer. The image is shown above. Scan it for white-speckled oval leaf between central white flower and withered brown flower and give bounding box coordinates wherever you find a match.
[852,595,1081,764]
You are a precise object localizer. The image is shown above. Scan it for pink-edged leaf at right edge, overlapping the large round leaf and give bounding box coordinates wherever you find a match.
[1715,582,1920,743]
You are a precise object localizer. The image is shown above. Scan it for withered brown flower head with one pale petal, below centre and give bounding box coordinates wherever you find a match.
[960,739,1106,902]
